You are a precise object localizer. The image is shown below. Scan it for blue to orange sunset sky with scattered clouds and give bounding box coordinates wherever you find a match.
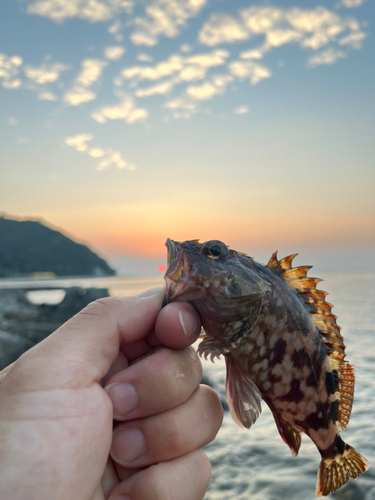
[0,0,375,270]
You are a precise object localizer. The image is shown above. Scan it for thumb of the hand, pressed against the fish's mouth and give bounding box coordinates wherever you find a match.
[4,288,164,390]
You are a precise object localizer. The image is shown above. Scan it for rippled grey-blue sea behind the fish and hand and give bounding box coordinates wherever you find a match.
[0,273,375,500]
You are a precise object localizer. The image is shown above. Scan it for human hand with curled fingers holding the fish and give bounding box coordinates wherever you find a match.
[0,291,222,500]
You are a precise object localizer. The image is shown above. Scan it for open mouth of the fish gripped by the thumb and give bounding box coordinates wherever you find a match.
[164,238,203,305]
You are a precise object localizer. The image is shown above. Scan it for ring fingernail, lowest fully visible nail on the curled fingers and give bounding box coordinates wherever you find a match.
[111,427,146,465]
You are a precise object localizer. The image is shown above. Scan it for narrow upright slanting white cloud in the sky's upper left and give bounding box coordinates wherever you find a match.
[64,59,108,106]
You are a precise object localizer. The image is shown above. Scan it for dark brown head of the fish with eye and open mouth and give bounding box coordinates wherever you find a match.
[165,239,270,328]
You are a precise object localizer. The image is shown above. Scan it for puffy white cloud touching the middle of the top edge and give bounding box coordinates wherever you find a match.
[130,0,207,47]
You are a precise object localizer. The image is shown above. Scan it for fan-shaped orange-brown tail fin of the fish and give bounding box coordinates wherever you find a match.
[315,443,369,497]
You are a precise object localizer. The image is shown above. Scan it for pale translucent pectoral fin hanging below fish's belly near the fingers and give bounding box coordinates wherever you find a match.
[225,354,262,429]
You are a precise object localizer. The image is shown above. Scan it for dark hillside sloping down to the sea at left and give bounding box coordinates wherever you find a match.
[0,216,115,277]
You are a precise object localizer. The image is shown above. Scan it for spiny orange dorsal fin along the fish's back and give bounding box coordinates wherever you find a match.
[267,252,354,429]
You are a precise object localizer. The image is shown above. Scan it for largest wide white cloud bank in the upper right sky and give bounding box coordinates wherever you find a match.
[198,6,366,63]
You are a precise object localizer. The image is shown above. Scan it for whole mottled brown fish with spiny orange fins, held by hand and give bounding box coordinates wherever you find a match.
[165,238,369,497]
